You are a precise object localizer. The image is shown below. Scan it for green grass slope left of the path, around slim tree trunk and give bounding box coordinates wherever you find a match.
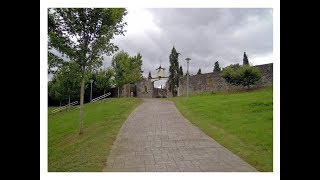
[48,98,142,172]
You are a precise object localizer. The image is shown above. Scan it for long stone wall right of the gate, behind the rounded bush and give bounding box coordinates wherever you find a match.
[178,63,273,96]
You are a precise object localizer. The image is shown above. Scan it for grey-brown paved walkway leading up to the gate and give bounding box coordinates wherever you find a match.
[104,99,256,172]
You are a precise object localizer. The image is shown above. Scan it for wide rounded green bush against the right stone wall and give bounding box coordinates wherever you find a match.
[222,66,261,89]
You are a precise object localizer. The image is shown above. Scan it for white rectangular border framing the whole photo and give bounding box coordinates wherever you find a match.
[40,0,280,180]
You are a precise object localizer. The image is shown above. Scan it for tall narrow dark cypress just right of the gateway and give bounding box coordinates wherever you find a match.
[168,46,180,96]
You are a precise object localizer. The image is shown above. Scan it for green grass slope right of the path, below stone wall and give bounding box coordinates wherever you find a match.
[169,87,273,171]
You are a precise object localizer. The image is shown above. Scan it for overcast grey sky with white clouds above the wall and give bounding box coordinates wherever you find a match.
[104,8,273,86]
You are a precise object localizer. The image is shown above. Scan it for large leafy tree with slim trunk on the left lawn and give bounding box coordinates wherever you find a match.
[48,8,127,134]
